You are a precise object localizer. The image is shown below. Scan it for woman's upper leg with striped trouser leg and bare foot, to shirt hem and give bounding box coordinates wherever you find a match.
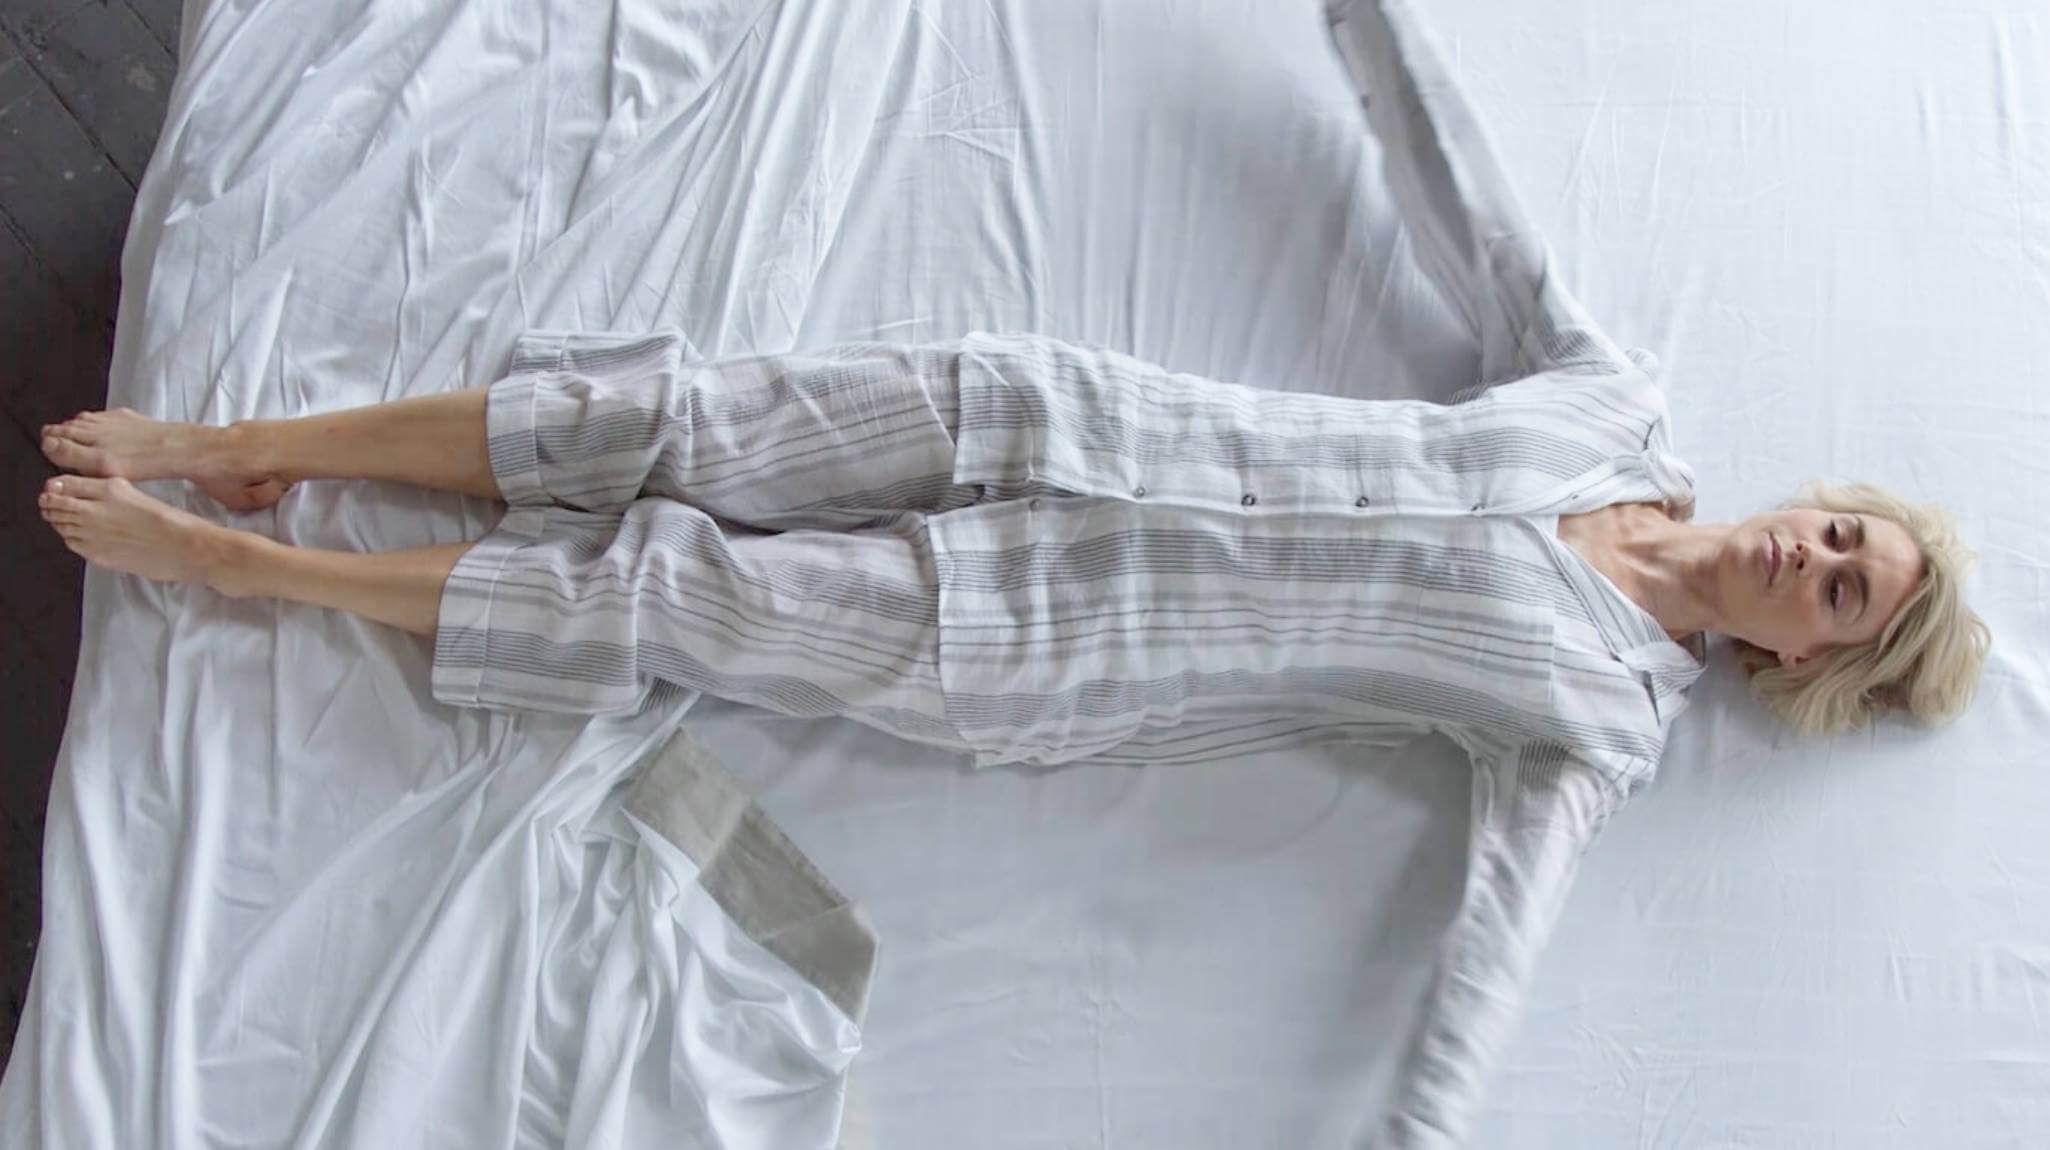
[43,336,982,522]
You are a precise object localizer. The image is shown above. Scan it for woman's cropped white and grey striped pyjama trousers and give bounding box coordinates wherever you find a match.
[433,336,986,750]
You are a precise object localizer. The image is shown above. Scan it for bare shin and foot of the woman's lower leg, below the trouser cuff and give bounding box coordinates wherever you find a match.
[39,476,469,635]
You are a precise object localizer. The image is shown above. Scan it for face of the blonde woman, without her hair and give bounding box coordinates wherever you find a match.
[1716,508,1921,666]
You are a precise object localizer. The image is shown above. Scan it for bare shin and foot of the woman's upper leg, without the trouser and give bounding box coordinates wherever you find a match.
[43,387,500,510]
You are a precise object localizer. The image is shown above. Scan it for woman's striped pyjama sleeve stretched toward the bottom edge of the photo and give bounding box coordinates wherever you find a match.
[1365,742,1624,1150]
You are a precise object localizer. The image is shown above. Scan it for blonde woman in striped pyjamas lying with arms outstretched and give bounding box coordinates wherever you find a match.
[28,0,1986,1146]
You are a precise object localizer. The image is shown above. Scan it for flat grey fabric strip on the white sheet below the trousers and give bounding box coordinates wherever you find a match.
[627,730,875,1023]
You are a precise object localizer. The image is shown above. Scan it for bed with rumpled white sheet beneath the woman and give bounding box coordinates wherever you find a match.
[0,0,2050,1150]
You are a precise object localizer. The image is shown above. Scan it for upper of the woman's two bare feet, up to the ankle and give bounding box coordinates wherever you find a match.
[43,408,291,510]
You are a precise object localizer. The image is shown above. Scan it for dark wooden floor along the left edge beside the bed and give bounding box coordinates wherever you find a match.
[0,0,180,1058]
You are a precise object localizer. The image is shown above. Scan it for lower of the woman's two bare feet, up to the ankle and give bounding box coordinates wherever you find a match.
[37,476,258,594]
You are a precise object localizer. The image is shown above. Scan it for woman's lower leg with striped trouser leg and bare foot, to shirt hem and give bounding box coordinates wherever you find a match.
[41,476,968,750]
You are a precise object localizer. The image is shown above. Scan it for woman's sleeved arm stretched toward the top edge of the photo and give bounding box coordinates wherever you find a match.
[1328,0,1632,383]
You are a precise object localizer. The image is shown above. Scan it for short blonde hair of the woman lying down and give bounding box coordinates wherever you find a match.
[1736,482,1993,734]
